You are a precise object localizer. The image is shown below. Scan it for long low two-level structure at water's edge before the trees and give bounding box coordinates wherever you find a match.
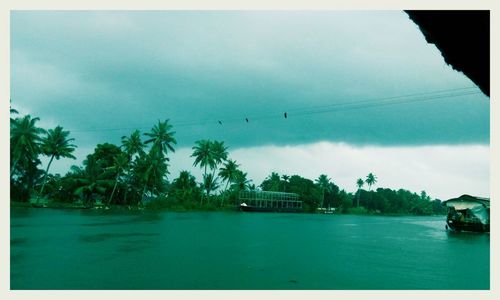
[239,191,303,212]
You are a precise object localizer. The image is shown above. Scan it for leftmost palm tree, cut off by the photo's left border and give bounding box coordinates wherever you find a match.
[10,115,45,179]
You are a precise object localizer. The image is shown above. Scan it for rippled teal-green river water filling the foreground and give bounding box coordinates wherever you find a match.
[10,208,490,290]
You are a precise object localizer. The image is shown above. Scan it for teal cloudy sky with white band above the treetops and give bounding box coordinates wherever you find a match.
[11,11,490,199]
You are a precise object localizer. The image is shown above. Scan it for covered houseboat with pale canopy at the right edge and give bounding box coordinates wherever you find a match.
[443,195,490,232]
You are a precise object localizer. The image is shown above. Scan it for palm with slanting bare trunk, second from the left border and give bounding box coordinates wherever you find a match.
[36,126,76,203]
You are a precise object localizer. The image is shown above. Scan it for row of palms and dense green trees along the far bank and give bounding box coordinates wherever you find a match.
[10,109,444,215]
